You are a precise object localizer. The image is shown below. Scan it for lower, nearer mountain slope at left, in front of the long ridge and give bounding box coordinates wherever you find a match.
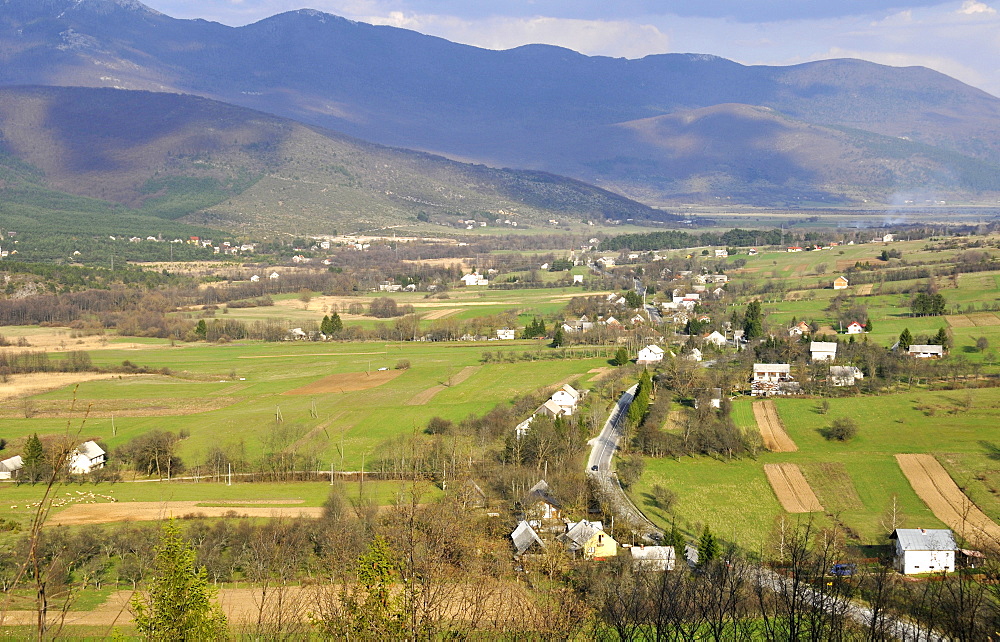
[0,86,674,233]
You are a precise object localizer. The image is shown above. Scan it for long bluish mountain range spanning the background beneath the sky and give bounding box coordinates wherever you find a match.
[0,0,1000,204]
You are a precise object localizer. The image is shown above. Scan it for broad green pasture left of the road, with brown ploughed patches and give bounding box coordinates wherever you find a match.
[0,341,607,470]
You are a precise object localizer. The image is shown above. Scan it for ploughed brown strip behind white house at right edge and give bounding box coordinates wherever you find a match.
[896,454,1000,546]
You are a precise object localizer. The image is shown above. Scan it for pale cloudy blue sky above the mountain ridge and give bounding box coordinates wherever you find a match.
[144,0,1000,97]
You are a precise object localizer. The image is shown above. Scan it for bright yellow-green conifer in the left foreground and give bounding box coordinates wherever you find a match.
[130,520,228,640]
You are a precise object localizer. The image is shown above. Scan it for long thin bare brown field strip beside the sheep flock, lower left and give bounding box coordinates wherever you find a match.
[46,500,323,526]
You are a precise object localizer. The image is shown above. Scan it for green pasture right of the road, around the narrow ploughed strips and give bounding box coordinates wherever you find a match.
[632,388,1000,549]
